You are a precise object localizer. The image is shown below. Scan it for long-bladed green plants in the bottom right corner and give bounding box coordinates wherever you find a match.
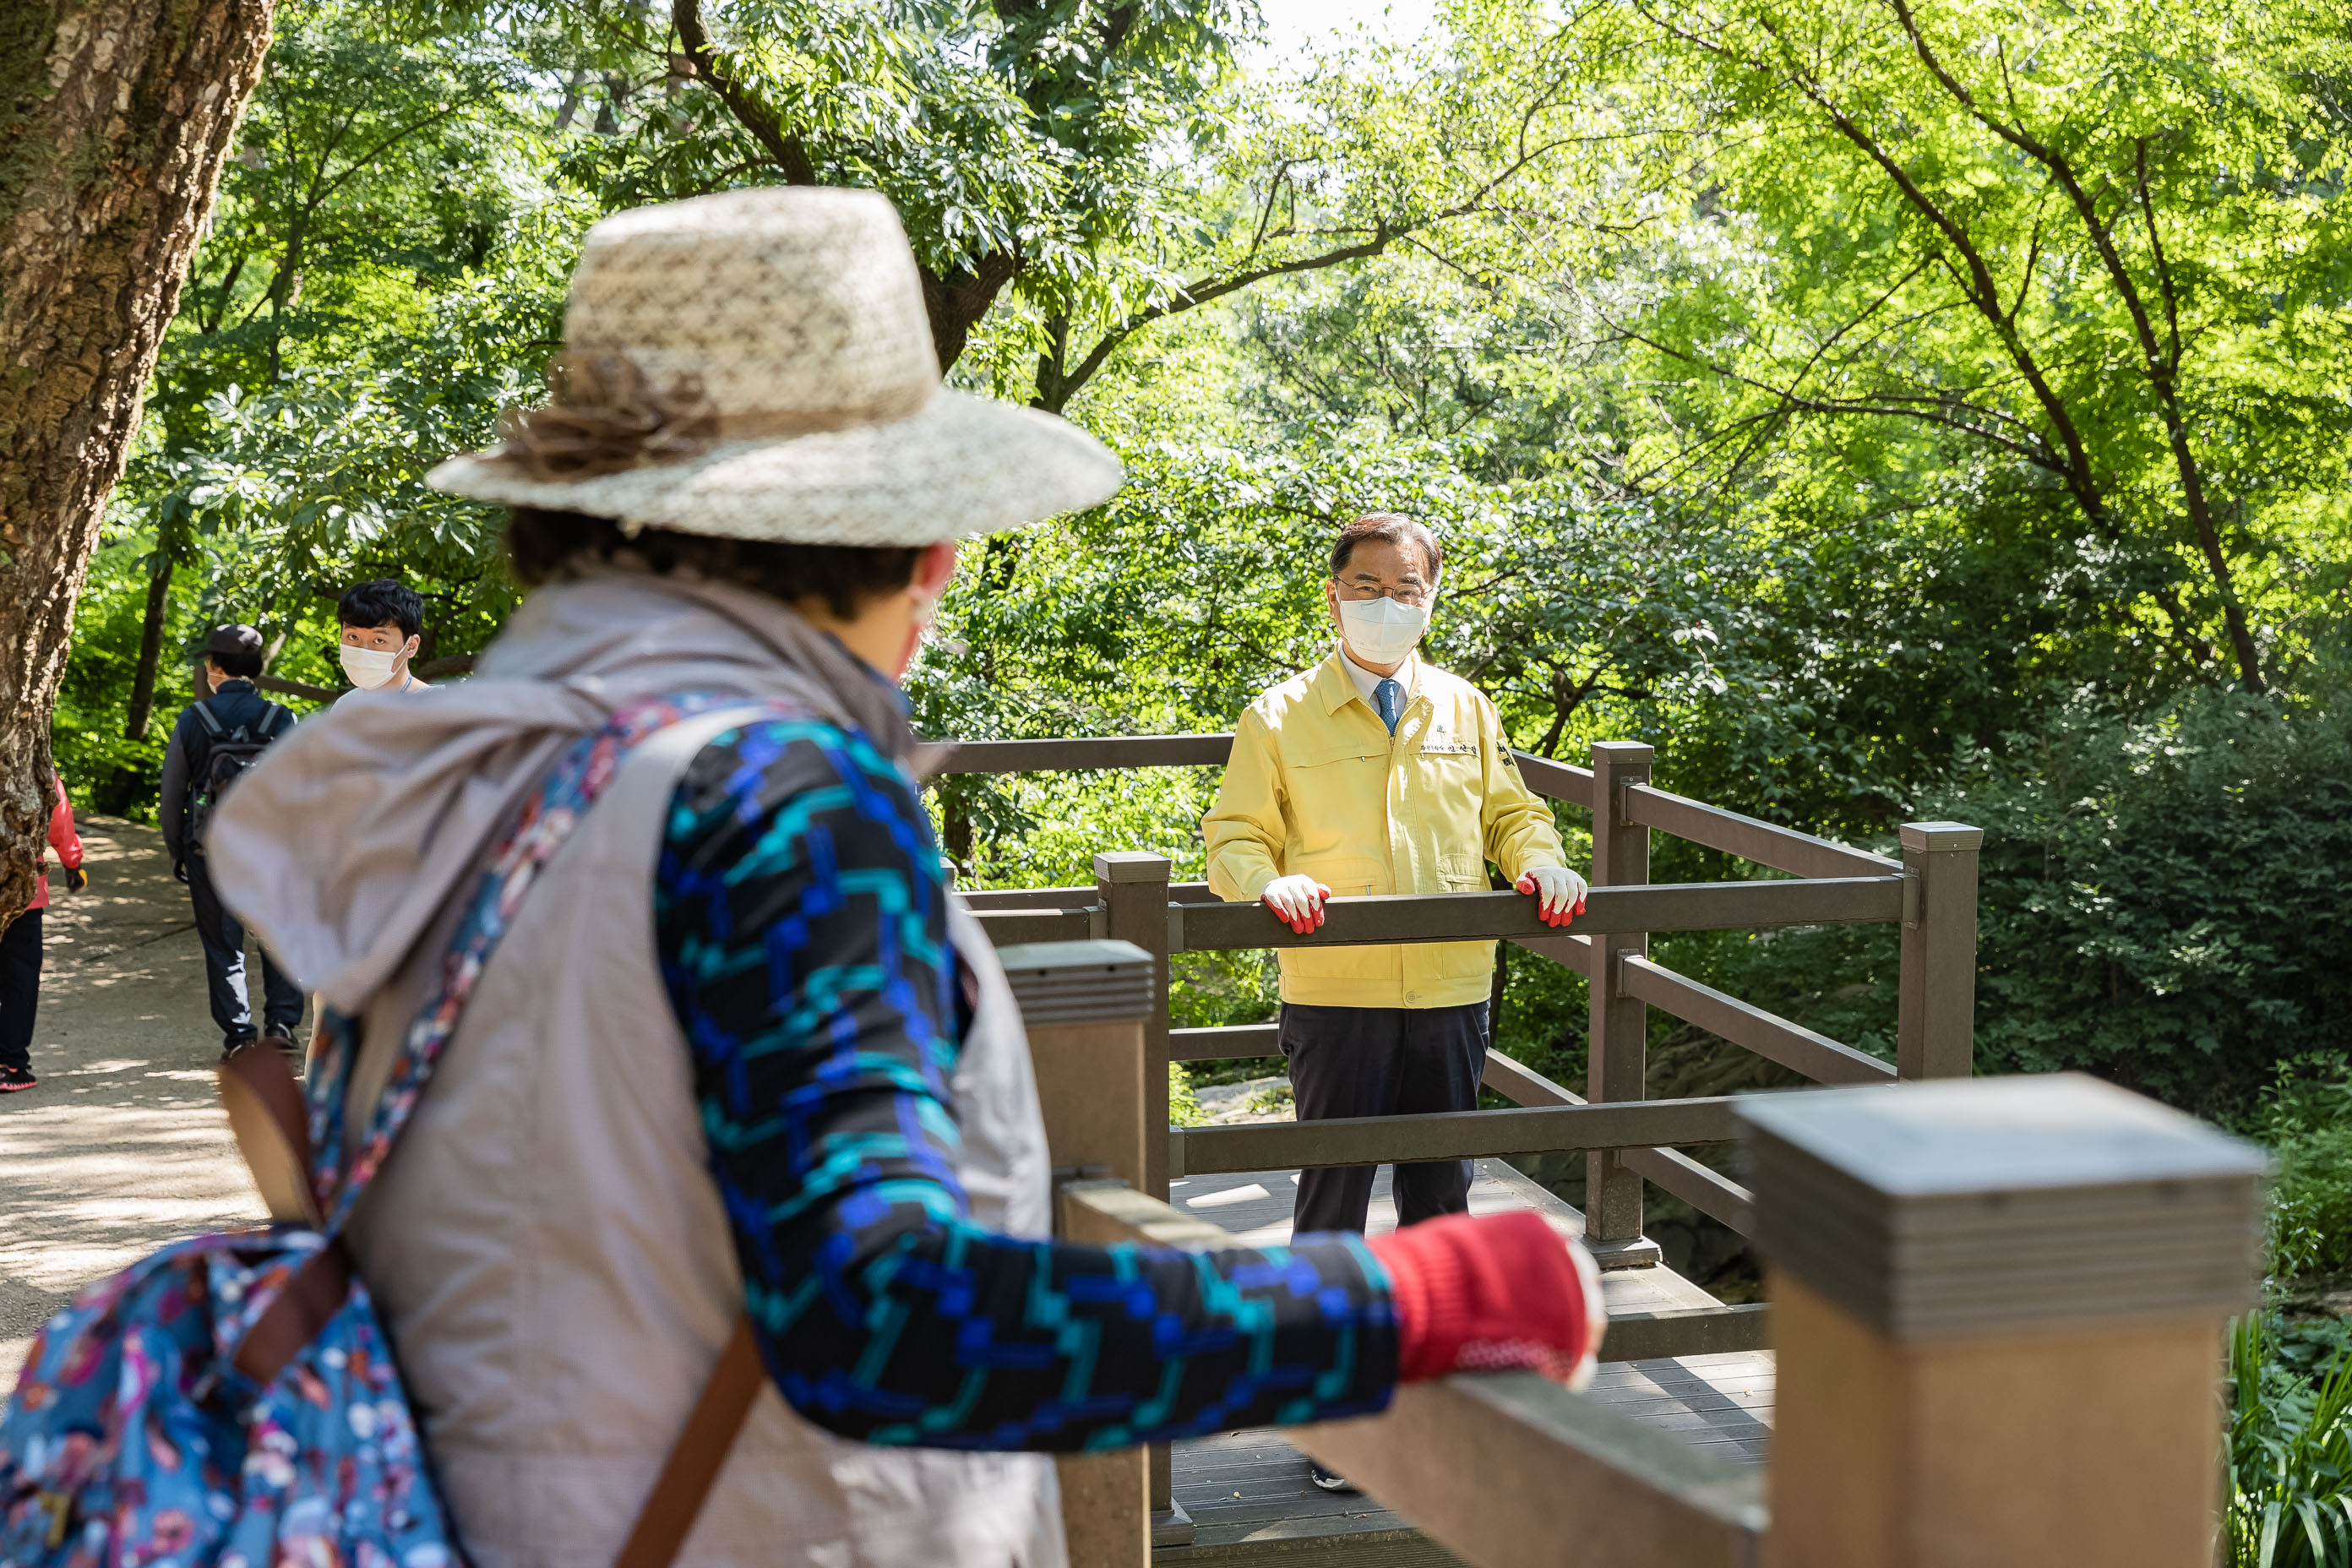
[2223,1316,2352,1568]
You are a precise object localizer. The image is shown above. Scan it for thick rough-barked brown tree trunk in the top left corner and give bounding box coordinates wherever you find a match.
[0,0,270,919]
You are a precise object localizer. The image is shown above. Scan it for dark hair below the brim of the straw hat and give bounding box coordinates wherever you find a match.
[506,505,924,621]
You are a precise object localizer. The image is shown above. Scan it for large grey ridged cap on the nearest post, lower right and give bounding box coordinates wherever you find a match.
[1736,1075,2268,1342]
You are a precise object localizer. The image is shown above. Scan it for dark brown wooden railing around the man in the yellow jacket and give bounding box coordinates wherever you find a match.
[939,736,1983,1278]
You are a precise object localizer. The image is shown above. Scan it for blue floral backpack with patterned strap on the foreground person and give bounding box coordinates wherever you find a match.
[0,698,760,1568]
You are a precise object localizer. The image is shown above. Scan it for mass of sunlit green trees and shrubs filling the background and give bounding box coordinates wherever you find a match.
[57,0,2352,1166]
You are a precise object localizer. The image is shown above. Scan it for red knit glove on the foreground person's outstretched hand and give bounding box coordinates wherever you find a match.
[1371,1208,1609,1390]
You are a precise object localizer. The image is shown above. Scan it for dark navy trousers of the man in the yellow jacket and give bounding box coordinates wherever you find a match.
[1282,1001,1489,1234]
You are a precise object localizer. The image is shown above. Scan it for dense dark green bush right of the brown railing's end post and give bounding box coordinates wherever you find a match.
[1924,691,2352,1114]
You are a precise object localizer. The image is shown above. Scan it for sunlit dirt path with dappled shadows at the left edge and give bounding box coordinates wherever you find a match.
[0,814,261,1390]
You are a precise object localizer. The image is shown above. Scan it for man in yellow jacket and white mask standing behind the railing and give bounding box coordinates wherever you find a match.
[1202,513,1585,1232]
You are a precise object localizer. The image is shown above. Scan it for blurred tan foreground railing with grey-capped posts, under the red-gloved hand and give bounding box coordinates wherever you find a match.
[1004,940,2265,1568]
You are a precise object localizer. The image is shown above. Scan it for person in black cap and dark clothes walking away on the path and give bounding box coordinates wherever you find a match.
[162,625,303,1055]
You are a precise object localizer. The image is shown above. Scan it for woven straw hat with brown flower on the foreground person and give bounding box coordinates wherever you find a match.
[426,186,1119,546]
